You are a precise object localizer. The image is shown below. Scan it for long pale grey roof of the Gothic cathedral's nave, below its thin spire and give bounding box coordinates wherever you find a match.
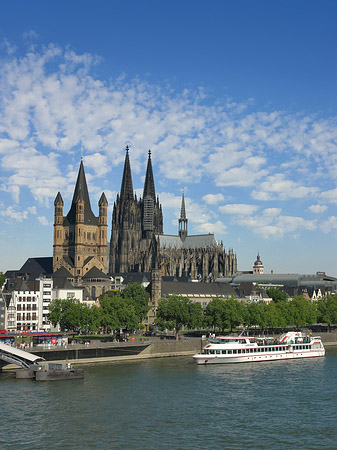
[156,233,218,249]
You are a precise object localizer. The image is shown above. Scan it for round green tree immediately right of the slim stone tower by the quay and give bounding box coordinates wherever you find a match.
[155,295,203,339]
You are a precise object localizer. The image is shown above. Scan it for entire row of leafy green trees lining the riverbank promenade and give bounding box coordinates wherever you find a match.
[49,284,337,335]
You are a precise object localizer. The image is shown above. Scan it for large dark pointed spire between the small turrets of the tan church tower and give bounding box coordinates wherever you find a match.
[67,160,97,225]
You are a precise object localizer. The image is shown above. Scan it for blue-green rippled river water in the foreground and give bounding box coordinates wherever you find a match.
[0,349,337,450]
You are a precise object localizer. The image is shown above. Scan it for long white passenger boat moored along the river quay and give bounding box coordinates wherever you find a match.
[193,331,325,364]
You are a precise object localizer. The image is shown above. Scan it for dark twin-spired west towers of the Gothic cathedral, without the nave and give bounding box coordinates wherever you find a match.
[109,147,163,273]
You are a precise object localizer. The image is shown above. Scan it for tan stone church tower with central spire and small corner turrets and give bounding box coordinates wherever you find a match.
[53,160,108,278]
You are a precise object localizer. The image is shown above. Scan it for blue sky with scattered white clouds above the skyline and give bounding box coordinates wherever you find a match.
[0,0,337,276]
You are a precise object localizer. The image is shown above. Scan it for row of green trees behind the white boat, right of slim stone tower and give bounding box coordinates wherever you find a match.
[156,295,337,332]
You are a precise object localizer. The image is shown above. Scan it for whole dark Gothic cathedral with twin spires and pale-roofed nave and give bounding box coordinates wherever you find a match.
[109,147,237,282]
